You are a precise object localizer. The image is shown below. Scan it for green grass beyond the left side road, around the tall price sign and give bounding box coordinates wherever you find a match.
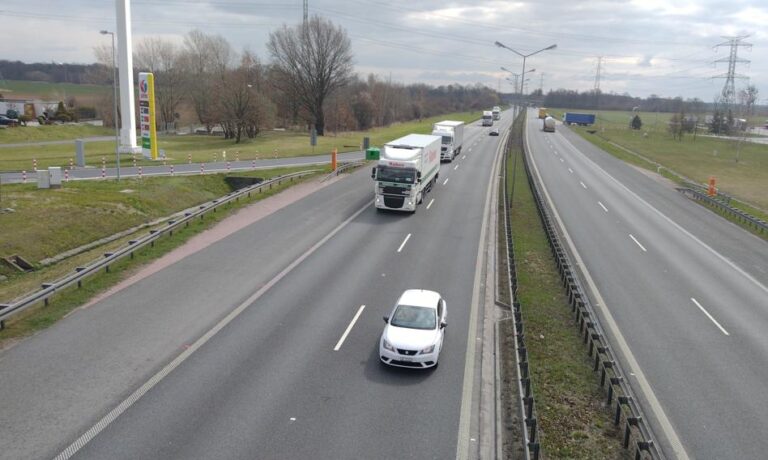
[0,112,481,171]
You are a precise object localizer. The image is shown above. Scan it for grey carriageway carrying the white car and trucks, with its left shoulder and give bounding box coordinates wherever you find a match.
[0,116,512,459]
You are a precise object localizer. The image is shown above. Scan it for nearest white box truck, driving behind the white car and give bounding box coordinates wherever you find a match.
[371,134,442,212]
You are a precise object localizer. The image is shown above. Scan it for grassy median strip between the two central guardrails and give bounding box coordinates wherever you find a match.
[500,113,627,460]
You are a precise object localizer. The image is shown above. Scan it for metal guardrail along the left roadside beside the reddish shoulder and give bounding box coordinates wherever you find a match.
[0,169,318,329]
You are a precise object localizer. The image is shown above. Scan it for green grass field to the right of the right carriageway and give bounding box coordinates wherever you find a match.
[550,109,768,210]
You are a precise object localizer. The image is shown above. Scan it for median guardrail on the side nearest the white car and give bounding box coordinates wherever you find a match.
[497,109,541,460]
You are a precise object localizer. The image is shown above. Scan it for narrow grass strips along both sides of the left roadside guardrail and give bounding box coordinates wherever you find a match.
[0,169,320,348]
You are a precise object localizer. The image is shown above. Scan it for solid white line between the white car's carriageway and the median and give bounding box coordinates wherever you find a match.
[456,121,509,460]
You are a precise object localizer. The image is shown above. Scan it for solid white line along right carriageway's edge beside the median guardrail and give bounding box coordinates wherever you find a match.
[524,114,690,460]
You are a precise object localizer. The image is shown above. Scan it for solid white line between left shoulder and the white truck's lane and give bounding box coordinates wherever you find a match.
[54,200,373,460]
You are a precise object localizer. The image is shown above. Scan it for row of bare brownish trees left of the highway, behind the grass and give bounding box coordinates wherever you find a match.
[82,16,500,142]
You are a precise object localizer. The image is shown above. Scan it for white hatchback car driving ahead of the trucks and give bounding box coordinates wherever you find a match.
[379,289,447,369]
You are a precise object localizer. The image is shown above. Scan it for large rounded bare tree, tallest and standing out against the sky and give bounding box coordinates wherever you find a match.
[267,16,353,136]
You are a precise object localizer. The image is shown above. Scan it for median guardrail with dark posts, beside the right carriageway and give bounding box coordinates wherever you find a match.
[523,114,664,460]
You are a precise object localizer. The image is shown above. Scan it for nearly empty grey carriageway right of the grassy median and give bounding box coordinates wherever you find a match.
[526,111,768,459]
